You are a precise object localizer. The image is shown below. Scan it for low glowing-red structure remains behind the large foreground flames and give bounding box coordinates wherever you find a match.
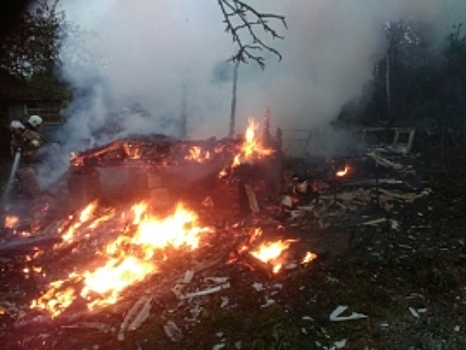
[68,120,280,215]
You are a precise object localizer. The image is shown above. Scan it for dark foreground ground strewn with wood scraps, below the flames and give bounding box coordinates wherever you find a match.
[0,148,466,349]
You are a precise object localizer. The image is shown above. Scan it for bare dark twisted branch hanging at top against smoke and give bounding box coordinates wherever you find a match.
[217,0,287,69]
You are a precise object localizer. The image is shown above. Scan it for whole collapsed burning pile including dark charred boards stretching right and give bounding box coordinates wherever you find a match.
[0,116,434,348]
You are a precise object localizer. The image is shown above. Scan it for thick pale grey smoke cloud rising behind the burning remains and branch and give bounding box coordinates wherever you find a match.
[37,0,466,186]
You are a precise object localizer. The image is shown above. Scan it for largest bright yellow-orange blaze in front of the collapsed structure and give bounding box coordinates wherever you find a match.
[31,202,212,317]
